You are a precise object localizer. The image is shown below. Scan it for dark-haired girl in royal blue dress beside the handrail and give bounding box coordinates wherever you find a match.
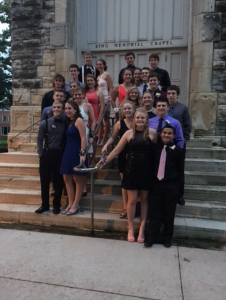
[60,100,86,216]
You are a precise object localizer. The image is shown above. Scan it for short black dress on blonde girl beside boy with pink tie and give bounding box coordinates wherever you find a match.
[122,131,152,191]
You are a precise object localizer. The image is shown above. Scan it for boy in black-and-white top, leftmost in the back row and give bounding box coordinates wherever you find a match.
[78,51,100,84]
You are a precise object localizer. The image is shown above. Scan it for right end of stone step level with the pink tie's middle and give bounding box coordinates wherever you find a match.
[185,158,226,172]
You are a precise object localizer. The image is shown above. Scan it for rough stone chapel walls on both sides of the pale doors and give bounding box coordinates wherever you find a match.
[8,0,226,151]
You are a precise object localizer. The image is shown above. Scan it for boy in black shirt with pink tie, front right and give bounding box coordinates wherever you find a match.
[144,125,184,248]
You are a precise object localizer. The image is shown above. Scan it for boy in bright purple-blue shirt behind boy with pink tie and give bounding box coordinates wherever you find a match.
[149,99,184,149]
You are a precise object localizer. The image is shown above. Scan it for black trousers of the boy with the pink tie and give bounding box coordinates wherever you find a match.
[149,180,179,240]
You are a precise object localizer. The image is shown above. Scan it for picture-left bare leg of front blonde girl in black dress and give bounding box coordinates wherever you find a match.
[127,190,138,242]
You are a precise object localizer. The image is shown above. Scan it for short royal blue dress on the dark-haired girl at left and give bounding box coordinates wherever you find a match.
[60,123,87,176]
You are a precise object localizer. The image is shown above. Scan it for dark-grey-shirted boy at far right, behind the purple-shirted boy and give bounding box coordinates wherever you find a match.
[166,85,192,205]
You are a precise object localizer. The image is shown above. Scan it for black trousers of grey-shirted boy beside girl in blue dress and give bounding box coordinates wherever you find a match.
[39,150,63,209]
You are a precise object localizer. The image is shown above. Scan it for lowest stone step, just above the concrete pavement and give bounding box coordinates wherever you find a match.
[0,203,226,242]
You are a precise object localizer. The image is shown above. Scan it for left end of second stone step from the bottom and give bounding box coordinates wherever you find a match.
[0,188,67,207]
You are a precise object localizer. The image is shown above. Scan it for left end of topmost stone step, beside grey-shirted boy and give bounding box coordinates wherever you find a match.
[0,152,39,164]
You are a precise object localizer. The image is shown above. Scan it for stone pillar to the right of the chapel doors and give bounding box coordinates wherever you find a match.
[190,0,226,142]
